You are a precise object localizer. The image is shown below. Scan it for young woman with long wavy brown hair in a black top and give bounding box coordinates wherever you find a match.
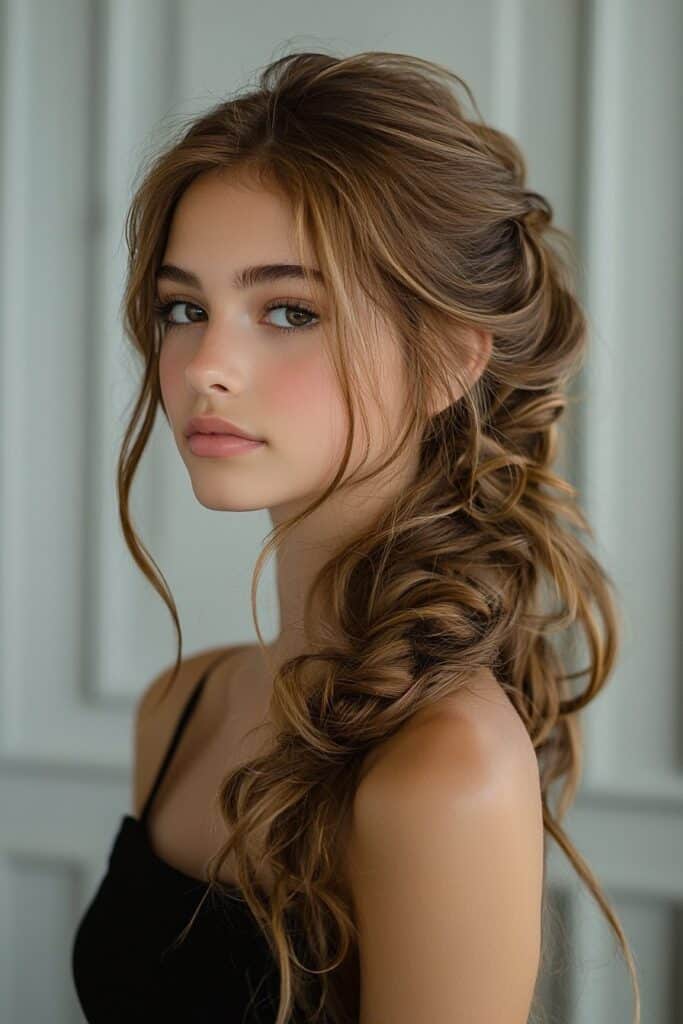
[74,46,639,1024]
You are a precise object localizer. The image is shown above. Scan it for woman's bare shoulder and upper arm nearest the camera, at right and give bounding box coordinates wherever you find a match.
[347,667,544,1024]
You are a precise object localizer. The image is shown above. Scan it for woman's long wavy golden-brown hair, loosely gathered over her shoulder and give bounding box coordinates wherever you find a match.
[118,51,640,1024]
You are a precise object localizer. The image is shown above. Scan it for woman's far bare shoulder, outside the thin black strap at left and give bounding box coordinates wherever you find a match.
[133,647,237,814]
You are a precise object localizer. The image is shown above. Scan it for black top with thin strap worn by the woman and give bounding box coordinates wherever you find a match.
[72,654,280,1024]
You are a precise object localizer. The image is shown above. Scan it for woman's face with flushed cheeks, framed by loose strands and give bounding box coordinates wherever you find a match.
[158,171,413,520]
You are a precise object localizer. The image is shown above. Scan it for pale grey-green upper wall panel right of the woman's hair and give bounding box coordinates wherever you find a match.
[583,2,683,790]
